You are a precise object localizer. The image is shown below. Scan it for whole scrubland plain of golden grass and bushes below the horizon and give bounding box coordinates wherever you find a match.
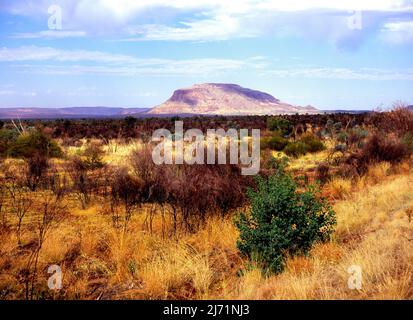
[0,108,413,299]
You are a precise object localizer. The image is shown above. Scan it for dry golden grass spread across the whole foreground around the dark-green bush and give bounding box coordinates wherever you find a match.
[0,146,413,299]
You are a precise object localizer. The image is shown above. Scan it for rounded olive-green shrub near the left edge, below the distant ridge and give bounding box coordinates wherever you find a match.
[7,130,63,158]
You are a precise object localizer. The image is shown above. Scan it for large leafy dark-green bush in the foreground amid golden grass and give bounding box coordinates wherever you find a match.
[236,172,336,273]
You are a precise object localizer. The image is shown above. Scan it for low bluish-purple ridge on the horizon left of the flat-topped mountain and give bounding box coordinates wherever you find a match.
[0,107,150,119]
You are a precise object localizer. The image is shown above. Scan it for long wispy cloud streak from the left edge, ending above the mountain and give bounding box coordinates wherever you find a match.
[0,46,258,76]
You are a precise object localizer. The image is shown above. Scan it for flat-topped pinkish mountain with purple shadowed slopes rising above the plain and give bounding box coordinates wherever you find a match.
[148,83,318,115]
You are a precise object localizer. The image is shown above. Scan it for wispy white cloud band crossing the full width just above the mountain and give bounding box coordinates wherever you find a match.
[0,46,413,79]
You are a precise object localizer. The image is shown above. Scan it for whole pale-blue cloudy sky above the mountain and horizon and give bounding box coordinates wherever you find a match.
[0,0,413,109]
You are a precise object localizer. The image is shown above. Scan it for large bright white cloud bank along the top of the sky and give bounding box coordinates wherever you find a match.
[0,0,413,41]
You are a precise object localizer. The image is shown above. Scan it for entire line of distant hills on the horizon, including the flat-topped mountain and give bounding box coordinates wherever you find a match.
[0,83,380,119]
